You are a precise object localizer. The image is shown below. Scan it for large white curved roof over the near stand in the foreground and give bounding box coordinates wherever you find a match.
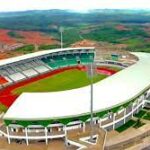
[4,53,150,120]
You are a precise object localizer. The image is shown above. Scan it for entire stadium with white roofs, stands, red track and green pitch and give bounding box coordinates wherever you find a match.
[0,47,150,149]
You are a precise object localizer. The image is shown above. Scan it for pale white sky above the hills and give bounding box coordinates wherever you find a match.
[0,0,150,12]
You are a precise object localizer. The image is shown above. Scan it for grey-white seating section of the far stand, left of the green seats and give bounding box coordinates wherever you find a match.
[0,60,51,86]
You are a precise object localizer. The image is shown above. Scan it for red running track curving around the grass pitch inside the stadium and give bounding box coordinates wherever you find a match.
[0,66,116,107]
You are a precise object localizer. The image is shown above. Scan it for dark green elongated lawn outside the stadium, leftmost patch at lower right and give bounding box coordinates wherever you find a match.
[116,120,136,132]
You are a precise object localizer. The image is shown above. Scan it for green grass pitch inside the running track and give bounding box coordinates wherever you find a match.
[12,69,107,95]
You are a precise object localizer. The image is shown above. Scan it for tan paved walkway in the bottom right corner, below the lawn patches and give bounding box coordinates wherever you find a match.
[105,123,150,150]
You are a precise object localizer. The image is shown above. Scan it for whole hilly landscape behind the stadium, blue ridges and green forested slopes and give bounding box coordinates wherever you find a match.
[0,9,150,53]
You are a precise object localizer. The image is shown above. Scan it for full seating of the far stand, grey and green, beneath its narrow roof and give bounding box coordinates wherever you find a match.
[0,50,94,88]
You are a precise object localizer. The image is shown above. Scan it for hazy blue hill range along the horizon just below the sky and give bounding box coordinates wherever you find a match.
[0,9,150,32]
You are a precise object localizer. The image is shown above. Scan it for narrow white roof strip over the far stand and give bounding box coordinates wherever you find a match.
[0,47,94,66]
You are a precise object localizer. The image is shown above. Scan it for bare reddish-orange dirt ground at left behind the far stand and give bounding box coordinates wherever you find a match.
[0,29,59,60]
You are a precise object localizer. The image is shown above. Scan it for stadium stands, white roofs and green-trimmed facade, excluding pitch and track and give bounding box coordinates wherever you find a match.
[0,47,150,145]
